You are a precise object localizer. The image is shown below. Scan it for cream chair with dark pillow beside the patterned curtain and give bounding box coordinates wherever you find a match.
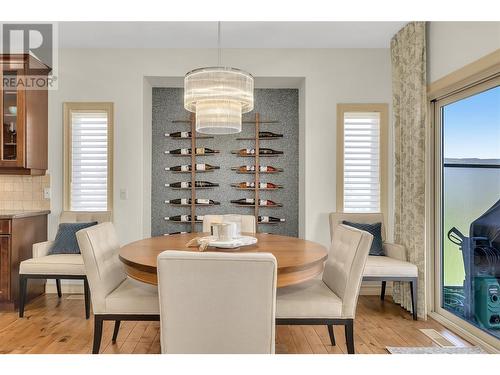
[330,212,418,320]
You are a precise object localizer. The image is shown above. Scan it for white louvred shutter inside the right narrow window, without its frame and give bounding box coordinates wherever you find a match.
[344,112,380,212]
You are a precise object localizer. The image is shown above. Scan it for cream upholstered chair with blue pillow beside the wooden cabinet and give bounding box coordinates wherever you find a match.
[19,211,111,319]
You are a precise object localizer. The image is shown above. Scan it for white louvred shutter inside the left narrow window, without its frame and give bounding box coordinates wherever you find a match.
[70,111,109,211]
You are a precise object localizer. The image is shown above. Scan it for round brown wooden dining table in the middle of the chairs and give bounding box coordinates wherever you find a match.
[120,233,328,288]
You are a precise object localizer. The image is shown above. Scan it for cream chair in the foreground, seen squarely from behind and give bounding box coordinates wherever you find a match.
[158,251,277,354]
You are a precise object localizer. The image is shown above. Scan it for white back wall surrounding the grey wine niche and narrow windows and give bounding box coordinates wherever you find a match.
[49,49,392,245]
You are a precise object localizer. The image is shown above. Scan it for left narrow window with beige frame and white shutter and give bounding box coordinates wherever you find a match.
[64,103,113,211]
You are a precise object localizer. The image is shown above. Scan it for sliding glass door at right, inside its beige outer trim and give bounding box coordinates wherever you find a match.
[434,78,500,346]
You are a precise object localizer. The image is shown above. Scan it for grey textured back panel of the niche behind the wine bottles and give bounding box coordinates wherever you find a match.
[151,88,300,236]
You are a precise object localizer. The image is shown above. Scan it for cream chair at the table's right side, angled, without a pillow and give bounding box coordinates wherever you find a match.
[276,225,373,354]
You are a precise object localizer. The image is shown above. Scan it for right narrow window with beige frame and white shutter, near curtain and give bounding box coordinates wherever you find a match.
[337,104,388,217]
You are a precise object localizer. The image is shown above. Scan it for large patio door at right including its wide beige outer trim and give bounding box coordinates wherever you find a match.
[426,51,500,351]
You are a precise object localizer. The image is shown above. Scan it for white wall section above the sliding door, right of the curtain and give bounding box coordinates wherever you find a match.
[427,22,500,83]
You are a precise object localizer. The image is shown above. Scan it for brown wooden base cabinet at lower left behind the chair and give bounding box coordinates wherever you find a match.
[0,211,49,310]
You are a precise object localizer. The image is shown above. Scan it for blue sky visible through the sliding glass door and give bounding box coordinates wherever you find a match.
[443,86,500,159]
